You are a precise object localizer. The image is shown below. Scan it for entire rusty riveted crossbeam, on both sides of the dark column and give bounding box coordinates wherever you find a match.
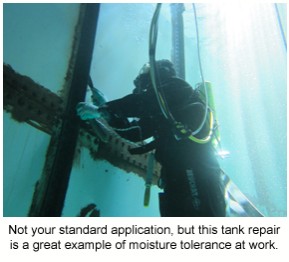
[3,65,160,184]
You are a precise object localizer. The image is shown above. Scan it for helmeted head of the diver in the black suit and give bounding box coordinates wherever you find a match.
[133,59,176,94]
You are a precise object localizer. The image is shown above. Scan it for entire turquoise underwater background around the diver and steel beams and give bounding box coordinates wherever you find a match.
[3,2,287,217]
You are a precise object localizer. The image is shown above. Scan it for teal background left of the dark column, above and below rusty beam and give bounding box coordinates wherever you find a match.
[3,4,79,216]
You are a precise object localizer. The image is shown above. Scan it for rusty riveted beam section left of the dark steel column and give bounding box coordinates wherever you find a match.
[3,65,63,134]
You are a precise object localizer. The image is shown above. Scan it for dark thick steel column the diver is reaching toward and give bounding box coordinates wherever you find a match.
[29,4,100,217]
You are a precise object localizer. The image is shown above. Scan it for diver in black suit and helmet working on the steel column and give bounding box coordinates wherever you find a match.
[77,59,226,217]
